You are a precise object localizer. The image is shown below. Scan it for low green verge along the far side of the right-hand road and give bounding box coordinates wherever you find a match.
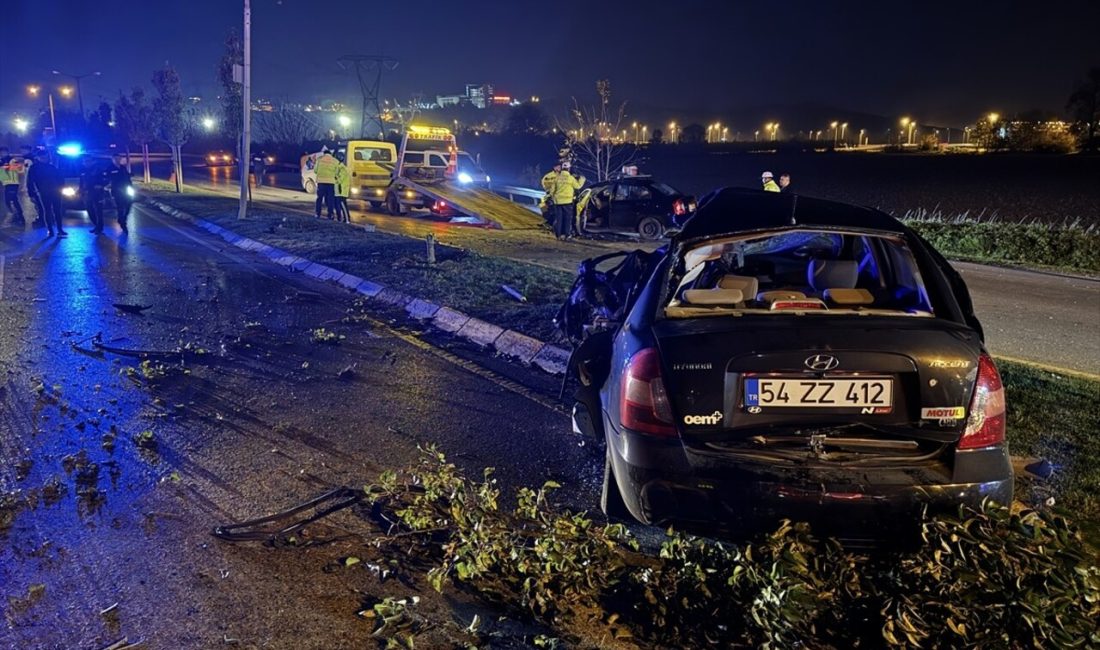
[902,210,1100,275]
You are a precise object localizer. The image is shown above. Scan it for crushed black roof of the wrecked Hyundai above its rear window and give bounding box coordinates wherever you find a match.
[677,187,909,241]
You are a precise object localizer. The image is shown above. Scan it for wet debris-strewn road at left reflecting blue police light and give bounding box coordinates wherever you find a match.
[0,206,601,649]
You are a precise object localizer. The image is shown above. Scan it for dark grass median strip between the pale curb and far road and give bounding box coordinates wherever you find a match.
[145,184,573,341]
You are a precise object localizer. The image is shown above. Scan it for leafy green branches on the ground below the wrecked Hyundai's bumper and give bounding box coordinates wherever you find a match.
[366,448,1100,648]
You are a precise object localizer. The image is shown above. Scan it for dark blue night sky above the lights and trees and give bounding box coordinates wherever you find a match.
[0,0,1100,124]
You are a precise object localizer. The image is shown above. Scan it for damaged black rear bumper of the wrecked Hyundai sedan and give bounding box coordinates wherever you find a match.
[609,432,1013,539]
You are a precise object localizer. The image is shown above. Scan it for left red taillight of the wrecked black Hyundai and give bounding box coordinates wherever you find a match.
[619,348,677,437]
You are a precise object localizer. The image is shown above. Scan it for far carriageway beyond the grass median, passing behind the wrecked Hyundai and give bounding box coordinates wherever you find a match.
[180,165,1100,376]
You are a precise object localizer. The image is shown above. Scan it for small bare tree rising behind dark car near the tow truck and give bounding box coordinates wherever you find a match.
[557,79,638,183]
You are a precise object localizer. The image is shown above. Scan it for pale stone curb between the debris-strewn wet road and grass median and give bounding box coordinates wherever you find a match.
[144,197,570,375]
